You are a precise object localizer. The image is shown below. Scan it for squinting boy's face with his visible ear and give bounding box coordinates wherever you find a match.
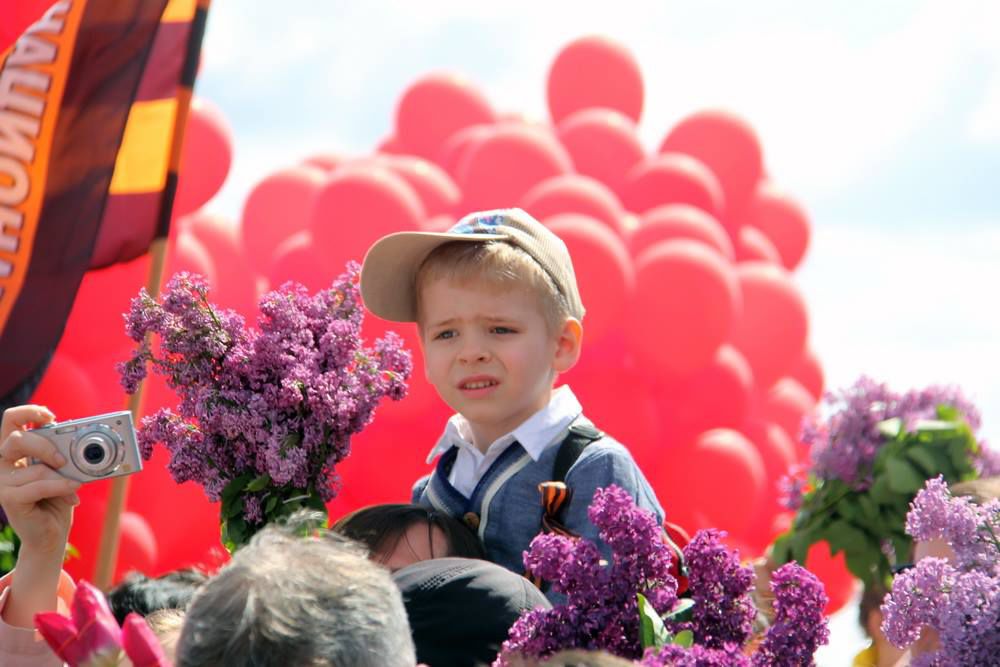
[420,279,580,450]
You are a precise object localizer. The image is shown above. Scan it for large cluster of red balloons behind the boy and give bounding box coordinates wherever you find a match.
[40,37,849,604]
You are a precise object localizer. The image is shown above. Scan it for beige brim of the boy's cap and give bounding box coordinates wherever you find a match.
[361,232,507,322]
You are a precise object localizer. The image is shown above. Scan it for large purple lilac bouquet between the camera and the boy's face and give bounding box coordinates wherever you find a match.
[118,262,412,550]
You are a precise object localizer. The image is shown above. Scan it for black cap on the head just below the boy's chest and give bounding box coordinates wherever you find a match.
[392,558,552,667]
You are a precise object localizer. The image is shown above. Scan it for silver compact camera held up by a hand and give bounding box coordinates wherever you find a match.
[31,410,142,482]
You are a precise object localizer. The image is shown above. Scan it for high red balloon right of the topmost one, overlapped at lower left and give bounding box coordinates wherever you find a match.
[660,110,764,219]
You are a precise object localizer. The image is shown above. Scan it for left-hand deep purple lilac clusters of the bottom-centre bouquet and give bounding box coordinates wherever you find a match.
[494,485,677,666]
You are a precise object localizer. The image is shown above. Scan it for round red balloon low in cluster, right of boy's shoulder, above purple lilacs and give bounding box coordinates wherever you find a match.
[654,428,766,535]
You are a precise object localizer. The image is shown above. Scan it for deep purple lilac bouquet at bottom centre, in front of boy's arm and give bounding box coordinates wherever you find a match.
[494,486,827,667]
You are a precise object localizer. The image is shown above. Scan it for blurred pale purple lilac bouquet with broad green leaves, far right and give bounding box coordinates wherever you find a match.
[772,377,1000,585]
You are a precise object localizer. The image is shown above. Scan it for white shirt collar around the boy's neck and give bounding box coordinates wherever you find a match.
[427,385,583,463]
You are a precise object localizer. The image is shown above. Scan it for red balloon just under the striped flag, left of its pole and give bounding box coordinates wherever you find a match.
[59,255,149,366]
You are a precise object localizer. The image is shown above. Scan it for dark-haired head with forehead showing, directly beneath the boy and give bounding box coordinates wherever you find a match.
[331,503,485,572]
